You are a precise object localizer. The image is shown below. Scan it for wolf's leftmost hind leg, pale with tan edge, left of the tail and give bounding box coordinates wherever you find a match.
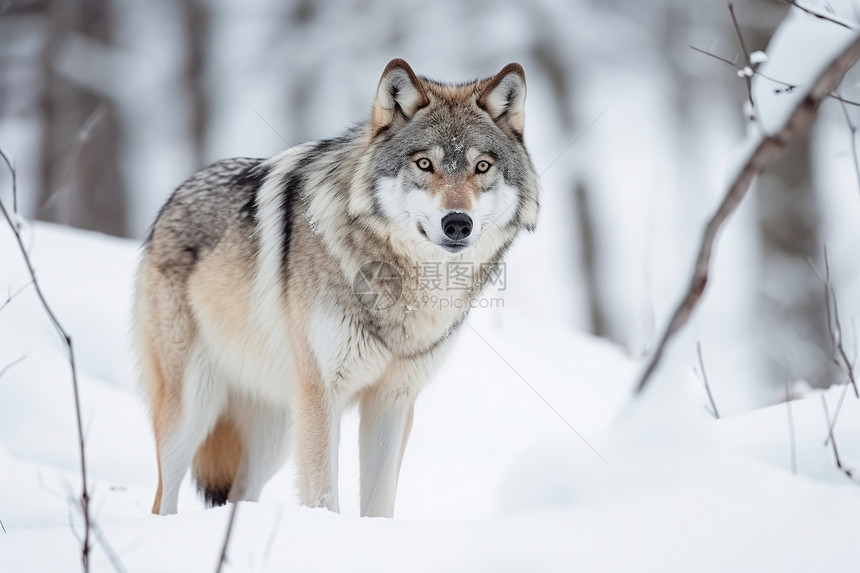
[153,350,226,515]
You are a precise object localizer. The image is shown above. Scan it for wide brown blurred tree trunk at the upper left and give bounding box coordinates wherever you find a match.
[35,0,127,236]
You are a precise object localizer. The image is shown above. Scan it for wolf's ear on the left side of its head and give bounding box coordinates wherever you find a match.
[370,58,430,137]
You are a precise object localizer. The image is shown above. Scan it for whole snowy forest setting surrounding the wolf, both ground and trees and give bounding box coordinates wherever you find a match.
[0,0,860,573]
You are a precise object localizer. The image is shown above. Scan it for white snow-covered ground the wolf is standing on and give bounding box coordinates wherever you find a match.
[0,224,860,573]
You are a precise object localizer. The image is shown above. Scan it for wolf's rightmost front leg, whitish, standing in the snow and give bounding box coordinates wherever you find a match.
[359,378,415,517]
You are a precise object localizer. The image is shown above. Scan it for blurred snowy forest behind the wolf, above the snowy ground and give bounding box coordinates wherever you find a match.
[6,0,860,412]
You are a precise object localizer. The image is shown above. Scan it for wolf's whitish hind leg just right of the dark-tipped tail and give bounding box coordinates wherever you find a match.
[228,398,291,503]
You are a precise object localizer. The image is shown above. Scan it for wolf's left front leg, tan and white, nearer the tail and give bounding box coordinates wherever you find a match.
[295,383,341,512]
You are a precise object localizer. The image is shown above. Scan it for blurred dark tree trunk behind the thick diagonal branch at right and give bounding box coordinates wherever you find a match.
[742,15,836,387]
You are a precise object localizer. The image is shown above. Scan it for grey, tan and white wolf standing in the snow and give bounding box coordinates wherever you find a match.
[132,59,539,517]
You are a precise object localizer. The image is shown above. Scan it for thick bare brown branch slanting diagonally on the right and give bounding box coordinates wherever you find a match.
[636,36,860,394]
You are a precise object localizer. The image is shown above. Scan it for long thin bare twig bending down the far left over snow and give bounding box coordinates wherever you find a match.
[0,151,91,573]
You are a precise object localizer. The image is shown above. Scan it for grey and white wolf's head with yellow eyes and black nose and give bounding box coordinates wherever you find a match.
[360,59,538,254]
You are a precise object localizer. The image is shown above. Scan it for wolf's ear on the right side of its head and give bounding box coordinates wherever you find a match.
[477,64,526,142]
